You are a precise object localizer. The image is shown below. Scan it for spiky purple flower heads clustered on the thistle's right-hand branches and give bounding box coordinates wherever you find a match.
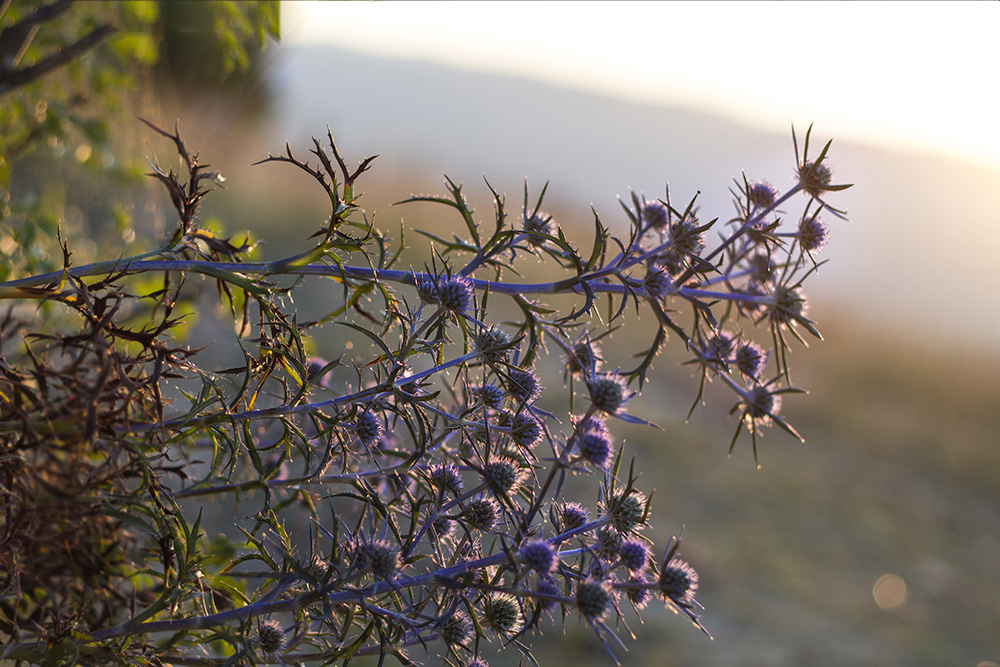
[219,126,842,667]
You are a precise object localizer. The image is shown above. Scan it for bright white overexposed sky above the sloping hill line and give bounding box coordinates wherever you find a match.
[282,1,1000,168]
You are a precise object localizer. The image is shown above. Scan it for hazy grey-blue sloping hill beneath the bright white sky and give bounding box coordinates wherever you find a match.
[271,46,1000,345]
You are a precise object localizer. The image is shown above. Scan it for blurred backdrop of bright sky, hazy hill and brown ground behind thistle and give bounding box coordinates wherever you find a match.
[7,2,1000,667]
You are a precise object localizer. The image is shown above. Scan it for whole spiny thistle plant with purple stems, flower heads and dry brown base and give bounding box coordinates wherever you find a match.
[0,124,848,667]
